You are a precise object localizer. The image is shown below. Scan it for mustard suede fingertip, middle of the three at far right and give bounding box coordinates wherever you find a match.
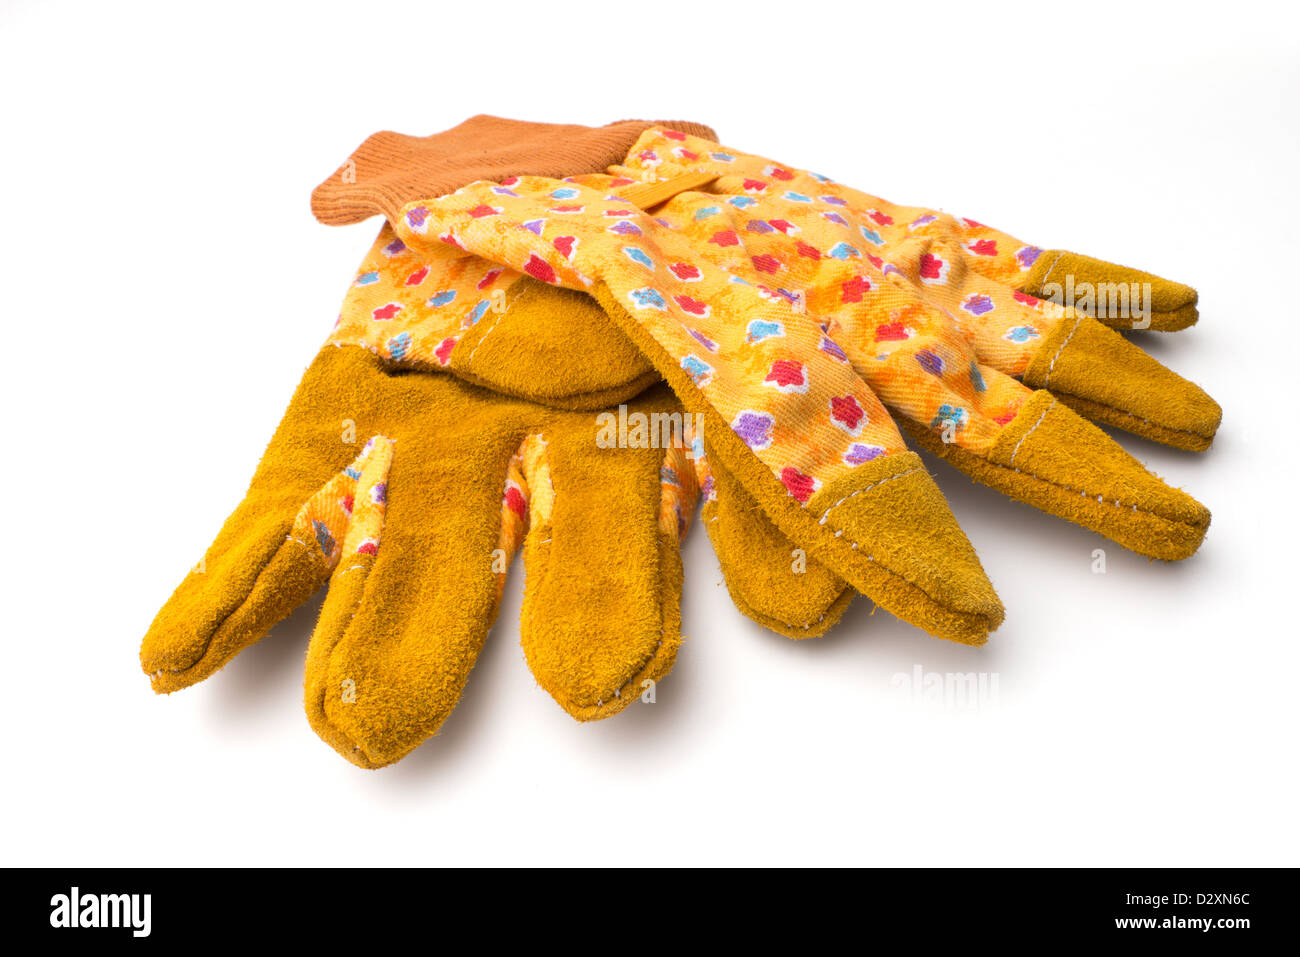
[1023,315,1223,451]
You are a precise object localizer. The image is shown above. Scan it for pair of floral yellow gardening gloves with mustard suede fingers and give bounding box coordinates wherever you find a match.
[140,117,1221,767]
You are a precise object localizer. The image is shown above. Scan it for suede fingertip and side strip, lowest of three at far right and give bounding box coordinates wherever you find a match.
[904,390,1210,559]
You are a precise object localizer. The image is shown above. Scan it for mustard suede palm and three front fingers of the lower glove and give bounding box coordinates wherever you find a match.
[140,346,696,767]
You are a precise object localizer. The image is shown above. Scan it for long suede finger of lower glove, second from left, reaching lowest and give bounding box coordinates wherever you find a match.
[304,361,536,767]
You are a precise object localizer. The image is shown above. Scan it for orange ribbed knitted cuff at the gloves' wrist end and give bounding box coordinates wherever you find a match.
[312,113,718,226]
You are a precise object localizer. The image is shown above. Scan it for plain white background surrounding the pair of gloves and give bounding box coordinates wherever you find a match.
[0,0,1300,865]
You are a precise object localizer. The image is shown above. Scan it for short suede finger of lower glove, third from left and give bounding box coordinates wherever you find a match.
[520,386,697,720]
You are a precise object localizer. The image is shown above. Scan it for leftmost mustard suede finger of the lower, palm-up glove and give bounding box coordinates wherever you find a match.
[140,348,390,692]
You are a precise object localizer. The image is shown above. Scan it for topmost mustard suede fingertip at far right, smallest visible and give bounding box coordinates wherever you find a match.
[1015,250,1197,332]
